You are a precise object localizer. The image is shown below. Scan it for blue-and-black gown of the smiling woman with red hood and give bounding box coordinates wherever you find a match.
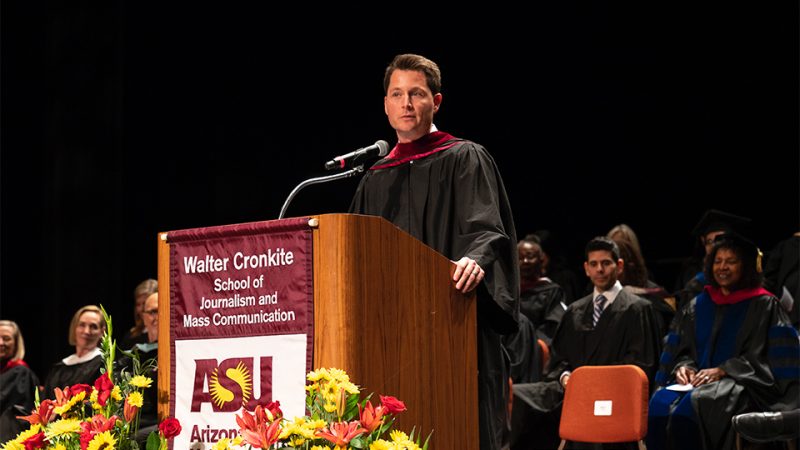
[647,292,800,450]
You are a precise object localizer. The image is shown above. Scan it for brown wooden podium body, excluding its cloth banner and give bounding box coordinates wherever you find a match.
[158,214,479,449]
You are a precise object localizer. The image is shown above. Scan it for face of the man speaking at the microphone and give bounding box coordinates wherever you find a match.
[383,70,442,143]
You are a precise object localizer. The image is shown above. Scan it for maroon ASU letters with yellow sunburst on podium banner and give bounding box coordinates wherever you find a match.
[191,356,272,412]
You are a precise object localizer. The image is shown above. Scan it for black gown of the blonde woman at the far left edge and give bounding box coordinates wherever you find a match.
[0,364,39,444]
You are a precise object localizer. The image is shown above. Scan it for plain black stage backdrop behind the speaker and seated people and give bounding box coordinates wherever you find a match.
[0,0,800,377]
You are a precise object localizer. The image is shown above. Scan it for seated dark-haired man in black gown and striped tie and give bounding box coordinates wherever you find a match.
[511,237,659,449]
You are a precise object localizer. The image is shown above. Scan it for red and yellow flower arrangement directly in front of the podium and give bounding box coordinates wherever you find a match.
[209,368,430,450]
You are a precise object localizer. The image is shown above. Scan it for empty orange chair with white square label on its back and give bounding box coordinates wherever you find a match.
[558,365,650,450]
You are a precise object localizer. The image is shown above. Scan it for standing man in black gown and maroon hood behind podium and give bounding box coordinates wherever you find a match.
[350,54,519,450]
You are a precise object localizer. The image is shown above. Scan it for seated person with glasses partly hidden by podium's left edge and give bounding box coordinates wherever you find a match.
[118,292,158,448]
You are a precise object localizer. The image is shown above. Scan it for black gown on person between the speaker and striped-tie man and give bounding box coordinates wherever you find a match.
[519,283,567,344]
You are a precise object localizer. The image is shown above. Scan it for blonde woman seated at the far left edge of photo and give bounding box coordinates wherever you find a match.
[0,320,39,443]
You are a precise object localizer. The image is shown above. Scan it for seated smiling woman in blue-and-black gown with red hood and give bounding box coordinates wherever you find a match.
[647,233,800,450]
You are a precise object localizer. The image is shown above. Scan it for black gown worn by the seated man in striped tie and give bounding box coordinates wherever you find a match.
[512,291,660,449]
